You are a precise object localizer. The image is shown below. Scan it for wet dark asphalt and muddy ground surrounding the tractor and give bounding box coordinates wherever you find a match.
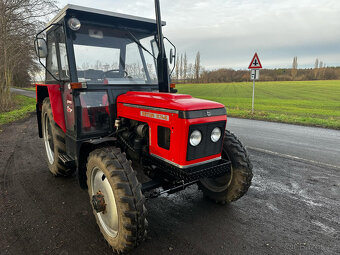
[0,88,340,255]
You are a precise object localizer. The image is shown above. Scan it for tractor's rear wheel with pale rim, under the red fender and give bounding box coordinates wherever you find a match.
[41,97,74,176]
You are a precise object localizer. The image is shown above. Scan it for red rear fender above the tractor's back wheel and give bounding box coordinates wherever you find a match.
[35,84,66,132]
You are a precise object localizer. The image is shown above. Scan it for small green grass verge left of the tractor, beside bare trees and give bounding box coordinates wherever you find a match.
[0,95,35,127]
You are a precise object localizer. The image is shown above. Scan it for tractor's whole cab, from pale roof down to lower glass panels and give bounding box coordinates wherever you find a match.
[36,5,171,141]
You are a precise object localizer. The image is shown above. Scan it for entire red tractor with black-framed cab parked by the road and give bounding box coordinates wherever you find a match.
[35,0,253,252]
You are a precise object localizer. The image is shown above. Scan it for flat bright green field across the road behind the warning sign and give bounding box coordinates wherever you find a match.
[176,80,340,129]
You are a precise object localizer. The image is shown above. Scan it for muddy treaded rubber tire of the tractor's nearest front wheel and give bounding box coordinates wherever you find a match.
[87,147,147,253]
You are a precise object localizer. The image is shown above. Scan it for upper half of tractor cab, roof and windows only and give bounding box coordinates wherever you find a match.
[41,5,165,86]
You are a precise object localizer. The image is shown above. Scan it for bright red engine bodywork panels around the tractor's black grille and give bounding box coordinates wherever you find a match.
[117,92,227,166]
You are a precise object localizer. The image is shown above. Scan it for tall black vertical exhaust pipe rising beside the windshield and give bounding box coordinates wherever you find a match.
[155,0,170,93]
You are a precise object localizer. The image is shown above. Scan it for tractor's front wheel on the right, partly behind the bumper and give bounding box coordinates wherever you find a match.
[199,130,253,204]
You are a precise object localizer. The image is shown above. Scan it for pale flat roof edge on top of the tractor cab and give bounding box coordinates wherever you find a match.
[46,4,166,27]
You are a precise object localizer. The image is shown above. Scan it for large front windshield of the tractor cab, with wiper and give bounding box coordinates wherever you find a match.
[73,25,158,84]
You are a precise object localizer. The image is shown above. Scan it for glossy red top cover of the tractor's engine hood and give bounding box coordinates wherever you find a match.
[117,91,224,111]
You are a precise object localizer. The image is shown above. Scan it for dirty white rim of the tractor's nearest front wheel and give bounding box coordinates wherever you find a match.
[91,167,119,237]
